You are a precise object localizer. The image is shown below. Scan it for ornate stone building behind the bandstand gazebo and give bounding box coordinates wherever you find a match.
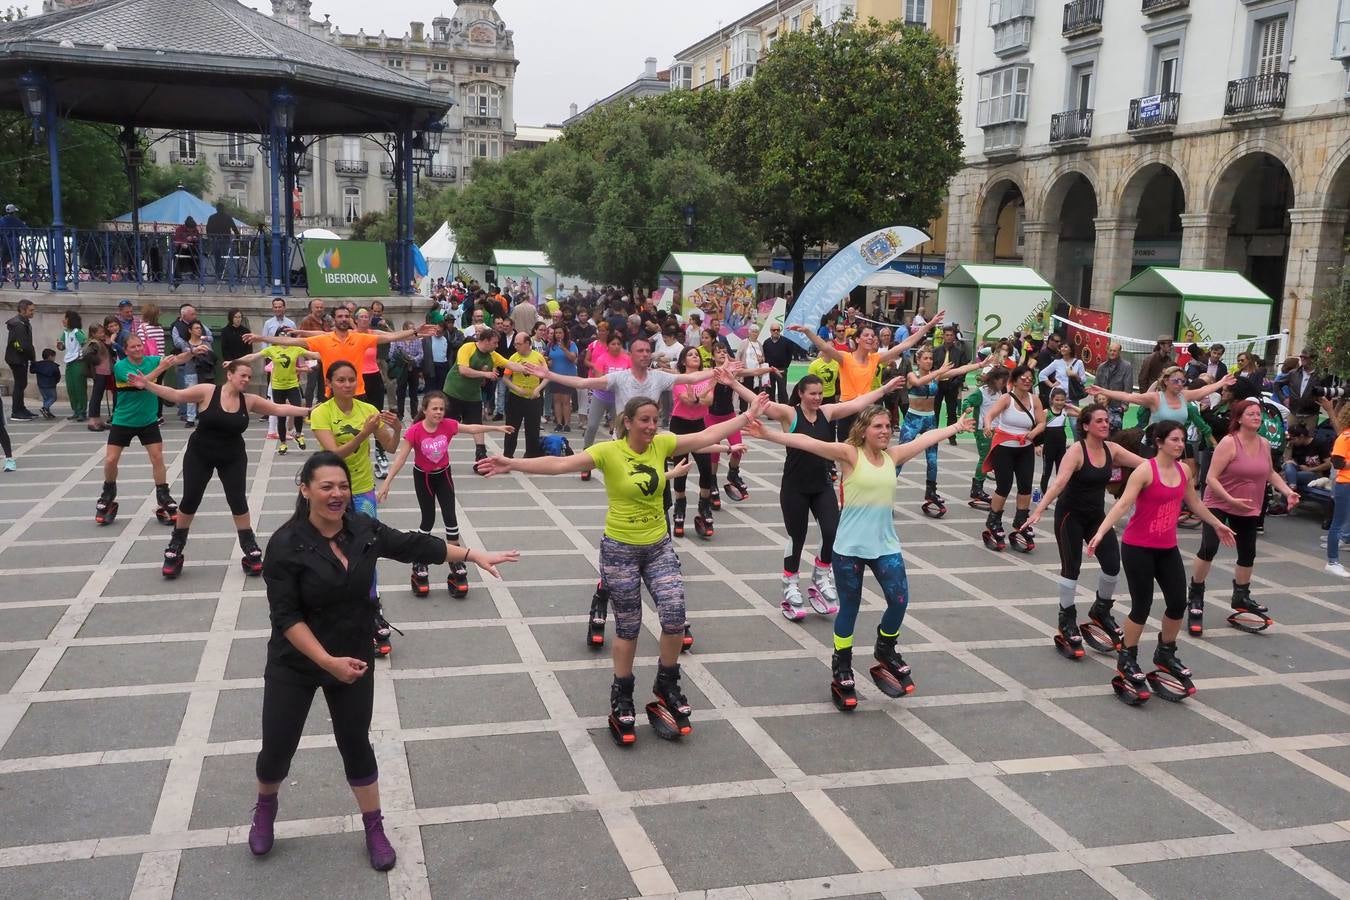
[43,0,520,232]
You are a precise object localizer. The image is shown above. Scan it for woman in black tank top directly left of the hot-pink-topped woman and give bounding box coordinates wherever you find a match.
[1027,405,1143,660]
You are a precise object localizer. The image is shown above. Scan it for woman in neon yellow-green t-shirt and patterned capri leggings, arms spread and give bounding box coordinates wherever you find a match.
[475,395,768,746]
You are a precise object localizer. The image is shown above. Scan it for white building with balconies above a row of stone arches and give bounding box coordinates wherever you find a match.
[946,0,1350,341]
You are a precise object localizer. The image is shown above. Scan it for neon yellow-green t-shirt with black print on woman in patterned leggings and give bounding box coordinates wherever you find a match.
[585,432,678,546]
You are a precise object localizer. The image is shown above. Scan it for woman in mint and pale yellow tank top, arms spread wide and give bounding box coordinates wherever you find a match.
[745,405,975,711]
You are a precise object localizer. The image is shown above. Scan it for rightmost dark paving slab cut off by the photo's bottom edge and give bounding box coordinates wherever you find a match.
[1119,853,1331,900]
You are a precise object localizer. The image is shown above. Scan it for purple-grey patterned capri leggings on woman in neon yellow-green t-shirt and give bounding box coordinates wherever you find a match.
[599,536,684,641]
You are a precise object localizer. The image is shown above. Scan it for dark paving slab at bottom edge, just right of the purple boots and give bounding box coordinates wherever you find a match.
[421,811,637,900]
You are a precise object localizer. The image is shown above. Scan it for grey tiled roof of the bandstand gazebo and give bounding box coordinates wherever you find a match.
[0,0,451,135]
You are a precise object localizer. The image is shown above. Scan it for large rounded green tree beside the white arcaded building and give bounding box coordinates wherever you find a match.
[718,20,963,290]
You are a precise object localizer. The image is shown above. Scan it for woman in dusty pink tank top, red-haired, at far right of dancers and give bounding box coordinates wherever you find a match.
[1187,399,1299,636]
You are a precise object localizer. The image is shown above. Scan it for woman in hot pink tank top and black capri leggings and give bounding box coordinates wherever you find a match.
[1088,421,1234,704]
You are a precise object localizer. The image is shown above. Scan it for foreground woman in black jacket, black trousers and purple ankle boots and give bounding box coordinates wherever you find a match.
[248,451,520,872]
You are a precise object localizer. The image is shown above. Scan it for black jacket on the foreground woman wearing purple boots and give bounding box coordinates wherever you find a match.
[262,513,446,684]
